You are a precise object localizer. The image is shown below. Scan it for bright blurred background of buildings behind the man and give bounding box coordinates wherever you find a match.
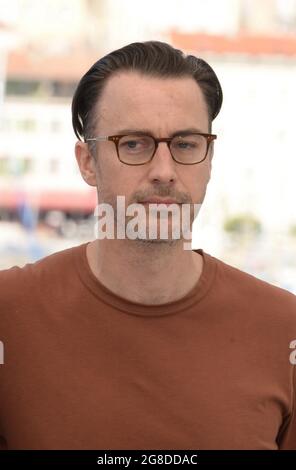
[0,0,296,293]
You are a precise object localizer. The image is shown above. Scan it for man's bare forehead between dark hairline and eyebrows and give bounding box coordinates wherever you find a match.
[96,72,207,127]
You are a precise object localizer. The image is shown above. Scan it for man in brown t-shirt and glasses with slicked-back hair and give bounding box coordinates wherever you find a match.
[0,41,296,449]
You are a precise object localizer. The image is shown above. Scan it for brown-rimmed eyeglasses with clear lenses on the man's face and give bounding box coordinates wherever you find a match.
[86,132,217,165]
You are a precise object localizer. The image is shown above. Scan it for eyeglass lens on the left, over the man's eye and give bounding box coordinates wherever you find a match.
[118,135,154,165]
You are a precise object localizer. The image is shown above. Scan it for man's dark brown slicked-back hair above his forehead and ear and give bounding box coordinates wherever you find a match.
[72,41,223,140]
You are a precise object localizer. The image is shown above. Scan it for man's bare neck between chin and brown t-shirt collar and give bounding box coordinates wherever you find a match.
[87,239,203,305]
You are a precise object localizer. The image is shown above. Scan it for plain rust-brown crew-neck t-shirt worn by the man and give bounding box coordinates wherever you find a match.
[0,244,296,450]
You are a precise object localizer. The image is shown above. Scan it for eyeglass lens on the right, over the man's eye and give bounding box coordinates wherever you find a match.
[171,134,207,165]
